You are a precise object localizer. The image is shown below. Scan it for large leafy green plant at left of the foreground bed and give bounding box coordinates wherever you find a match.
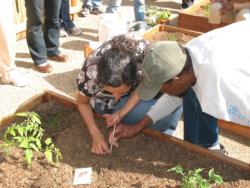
[1,112,62,165]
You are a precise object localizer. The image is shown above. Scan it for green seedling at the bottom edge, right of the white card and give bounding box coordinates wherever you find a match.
[168,165,223,188]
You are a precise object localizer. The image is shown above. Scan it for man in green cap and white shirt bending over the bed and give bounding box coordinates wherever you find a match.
[109,21,250,149]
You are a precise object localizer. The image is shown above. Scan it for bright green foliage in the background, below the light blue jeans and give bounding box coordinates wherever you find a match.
[145,6,171,26]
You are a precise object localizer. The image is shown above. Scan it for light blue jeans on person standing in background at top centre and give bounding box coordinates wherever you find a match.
[106,0,145,21]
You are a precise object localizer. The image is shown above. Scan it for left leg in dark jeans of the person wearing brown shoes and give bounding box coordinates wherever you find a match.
[25,0,47,65]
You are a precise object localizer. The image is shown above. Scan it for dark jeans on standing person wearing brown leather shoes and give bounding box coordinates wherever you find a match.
[25,0,61,65]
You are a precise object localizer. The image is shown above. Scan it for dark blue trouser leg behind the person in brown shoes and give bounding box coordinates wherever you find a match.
[59,0,75,31]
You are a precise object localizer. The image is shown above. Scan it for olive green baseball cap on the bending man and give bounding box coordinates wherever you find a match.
[137,41,187,100]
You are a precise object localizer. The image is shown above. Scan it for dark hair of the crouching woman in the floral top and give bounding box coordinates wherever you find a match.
[97,48,139,87]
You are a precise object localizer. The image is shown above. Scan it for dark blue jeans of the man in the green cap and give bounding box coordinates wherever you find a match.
[183,88,218,148]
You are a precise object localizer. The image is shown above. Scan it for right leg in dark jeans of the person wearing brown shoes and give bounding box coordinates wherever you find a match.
[44,0,61,56]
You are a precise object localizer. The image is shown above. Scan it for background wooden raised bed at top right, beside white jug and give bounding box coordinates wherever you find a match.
[178,0,231,32]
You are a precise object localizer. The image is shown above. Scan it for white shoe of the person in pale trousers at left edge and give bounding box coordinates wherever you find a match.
[2,69,29,87]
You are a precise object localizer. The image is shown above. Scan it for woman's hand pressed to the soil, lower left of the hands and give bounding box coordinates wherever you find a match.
[91,133,110,155]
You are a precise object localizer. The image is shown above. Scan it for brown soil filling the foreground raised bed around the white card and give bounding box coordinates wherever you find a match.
[0,102,250,188]
